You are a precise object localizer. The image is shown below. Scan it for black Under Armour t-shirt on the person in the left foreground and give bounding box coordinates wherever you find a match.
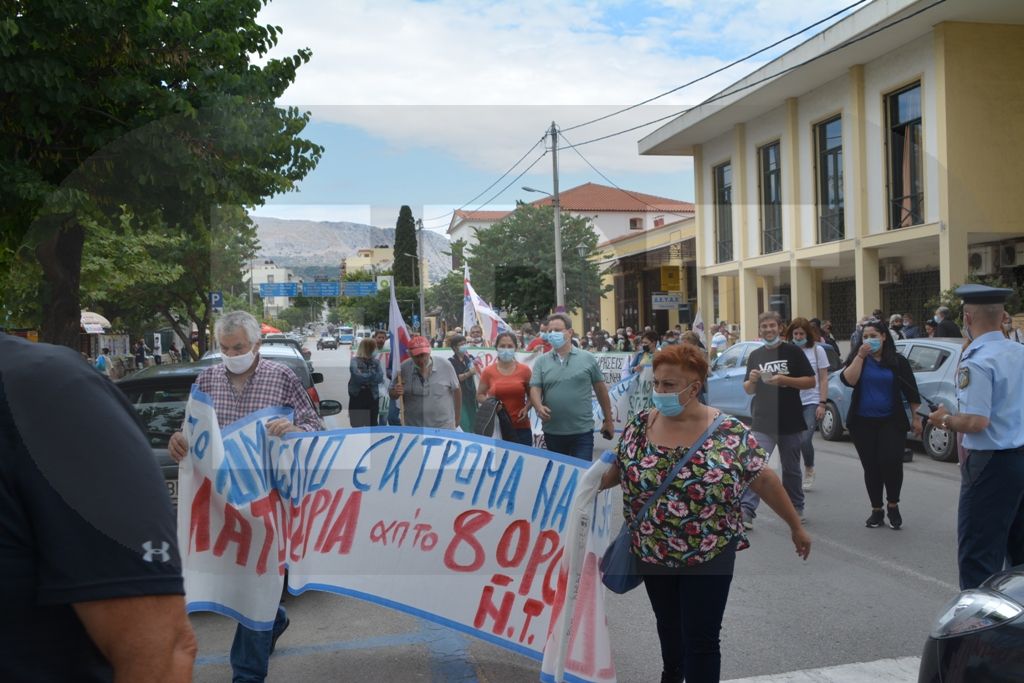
[0,334,184,683]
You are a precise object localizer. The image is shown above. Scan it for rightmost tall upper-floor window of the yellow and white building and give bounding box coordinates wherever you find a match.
[886,83,925,229]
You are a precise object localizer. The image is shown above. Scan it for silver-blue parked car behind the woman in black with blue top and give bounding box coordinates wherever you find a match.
[821,338,963,462]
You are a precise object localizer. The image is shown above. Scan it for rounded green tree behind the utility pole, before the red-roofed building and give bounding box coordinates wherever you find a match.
[467,202,610,321]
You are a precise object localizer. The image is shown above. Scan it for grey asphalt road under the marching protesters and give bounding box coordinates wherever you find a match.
[191,347,959,683]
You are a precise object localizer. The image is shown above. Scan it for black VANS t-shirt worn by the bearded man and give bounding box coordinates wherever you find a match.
[743,342,814,435]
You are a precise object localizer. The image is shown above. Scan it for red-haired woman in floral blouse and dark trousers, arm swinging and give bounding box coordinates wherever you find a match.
[601,344,811,683]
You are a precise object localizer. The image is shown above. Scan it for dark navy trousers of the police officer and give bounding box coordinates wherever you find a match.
[956,449,1024,590]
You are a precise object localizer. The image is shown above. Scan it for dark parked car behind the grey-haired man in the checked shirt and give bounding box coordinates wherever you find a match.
[117,356,342,504]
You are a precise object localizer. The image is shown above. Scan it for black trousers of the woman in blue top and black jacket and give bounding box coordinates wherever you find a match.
[850,418,906,508]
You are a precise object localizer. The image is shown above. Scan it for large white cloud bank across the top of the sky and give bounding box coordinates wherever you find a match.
[253,0,848,179]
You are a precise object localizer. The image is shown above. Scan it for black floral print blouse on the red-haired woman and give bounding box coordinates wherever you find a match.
[615,411,768,567]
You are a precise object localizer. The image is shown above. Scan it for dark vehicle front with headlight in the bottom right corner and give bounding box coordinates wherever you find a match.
[914,565,1024,683]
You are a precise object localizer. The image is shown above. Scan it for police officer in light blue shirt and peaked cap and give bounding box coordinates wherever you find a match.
[928,285,1024,589]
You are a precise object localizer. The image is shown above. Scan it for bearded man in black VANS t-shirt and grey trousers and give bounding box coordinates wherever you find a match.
[740,310,814,528]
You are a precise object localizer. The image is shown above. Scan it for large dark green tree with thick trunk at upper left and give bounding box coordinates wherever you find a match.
[0,0,323,346]
